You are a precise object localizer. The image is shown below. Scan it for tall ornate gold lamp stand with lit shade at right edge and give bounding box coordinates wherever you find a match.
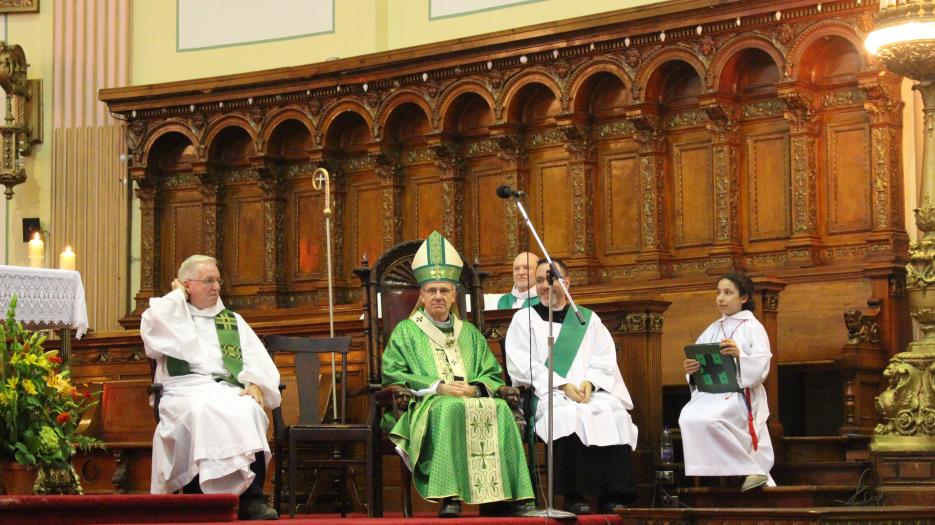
[866,0,935,456]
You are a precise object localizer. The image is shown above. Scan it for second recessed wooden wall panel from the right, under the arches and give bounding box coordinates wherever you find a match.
[745,133,791,241]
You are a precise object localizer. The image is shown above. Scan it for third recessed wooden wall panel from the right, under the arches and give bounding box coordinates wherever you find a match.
[672,142,716,247]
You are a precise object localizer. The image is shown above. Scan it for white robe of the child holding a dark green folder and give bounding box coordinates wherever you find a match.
[679,310,776,486]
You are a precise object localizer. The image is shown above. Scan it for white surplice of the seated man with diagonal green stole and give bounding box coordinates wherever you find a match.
[505,307,638,449]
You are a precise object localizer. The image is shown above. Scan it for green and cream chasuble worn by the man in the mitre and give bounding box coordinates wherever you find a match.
[383,310,533,504]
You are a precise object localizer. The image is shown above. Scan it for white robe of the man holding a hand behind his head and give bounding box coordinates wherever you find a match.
[140,289,282,494]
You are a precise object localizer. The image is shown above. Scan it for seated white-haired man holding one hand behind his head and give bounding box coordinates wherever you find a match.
[140,255,281,519]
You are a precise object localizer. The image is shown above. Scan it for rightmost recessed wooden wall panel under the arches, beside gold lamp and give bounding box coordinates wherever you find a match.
[825,122,872,233]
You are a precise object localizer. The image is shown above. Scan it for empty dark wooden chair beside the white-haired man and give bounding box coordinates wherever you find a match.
[266,335,377,517]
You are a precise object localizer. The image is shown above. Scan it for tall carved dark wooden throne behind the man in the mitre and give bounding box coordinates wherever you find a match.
[354,239,525,517]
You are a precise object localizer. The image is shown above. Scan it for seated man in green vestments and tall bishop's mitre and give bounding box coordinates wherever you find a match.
[383,232,533,517]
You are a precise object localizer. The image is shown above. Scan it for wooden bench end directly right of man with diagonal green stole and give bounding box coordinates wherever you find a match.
[616,300,671,465]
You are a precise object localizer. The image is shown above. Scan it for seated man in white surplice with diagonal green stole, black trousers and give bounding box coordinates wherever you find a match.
[506,259,637,514]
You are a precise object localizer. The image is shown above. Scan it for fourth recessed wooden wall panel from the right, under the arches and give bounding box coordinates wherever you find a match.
[600,153,642,255]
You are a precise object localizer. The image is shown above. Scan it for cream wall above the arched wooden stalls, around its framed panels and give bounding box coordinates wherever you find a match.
[131,0,660,84]
